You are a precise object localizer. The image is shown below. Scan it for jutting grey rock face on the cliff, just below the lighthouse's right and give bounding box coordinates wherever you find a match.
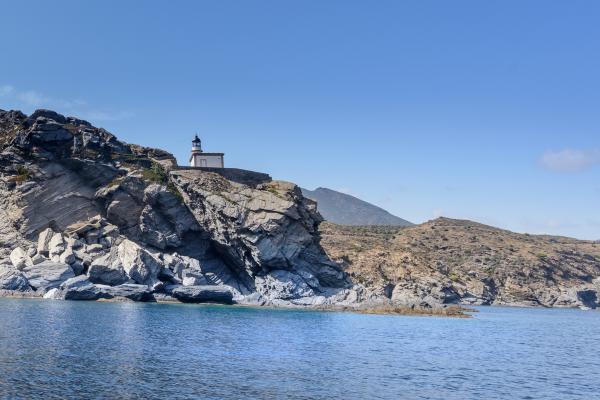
[171,170,348,296]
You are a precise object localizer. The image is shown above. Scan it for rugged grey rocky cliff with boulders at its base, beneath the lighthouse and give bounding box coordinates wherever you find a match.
[0,110,358,305]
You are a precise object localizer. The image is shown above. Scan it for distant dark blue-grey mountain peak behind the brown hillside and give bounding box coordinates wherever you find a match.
[302,188,413,226]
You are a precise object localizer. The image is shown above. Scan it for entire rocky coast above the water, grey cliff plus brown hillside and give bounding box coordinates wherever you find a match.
[0,110,600,314]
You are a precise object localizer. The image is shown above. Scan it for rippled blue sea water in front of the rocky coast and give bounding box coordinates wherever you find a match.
[0,299,600,400]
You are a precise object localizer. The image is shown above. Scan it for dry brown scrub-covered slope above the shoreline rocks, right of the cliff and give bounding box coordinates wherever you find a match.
[320,218,600,302]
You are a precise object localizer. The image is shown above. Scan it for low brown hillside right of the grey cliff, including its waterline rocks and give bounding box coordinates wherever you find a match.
[319,218,600,308]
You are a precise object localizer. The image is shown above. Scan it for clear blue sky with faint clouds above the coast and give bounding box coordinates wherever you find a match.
[0,0,600,239]
